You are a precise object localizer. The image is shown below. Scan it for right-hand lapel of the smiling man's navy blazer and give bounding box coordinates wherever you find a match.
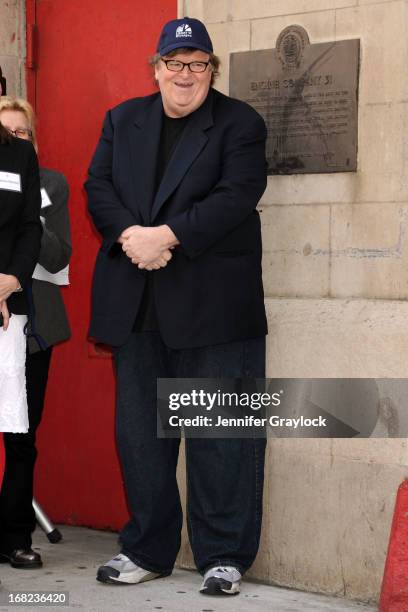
[151,90,213,222]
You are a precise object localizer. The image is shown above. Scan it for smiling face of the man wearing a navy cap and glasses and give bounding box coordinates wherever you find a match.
[155,50,212,117]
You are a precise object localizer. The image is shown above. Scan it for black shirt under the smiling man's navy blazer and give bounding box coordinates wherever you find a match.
[133,113,190,331]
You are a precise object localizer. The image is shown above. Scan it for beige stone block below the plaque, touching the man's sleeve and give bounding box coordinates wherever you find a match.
[261,206,330,297]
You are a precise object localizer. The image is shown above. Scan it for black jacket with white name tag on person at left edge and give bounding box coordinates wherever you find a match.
[0,138,42,314]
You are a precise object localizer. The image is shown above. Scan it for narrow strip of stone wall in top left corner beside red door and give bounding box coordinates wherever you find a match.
[0,0,26,96]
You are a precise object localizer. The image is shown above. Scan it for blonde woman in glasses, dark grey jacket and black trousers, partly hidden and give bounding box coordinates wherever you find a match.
[0,96,71,568]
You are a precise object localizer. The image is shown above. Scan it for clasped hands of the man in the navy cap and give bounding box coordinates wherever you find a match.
[118,225,179,270]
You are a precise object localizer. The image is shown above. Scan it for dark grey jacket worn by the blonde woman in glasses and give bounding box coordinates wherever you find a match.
[28,168,72,353]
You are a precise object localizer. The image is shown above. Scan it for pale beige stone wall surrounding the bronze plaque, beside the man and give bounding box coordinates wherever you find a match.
[179,0,408,601]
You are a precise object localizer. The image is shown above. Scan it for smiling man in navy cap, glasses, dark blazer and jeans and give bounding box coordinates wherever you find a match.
[86,17,267,594]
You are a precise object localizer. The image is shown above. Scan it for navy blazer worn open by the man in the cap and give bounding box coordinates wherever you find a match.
[85,89,267,349]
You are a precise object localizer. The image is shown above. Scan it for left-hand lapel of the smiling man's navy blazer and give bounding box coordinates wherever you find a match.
[129,94,163,226]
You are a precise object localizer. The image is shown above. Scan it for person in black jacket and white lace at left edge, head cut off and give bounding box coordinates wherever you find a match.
[0,123,42,482]
